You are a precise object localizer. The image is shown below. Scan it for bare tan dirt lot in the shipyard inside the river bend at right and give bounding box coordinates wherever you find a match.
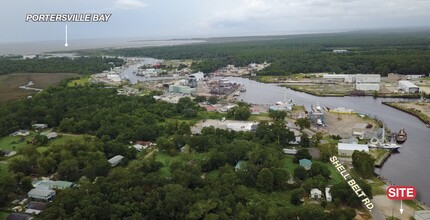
[322,112,376,138]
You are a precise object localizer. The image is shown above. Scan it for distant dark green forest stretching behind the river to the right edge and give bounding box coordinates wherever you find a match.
[98,31,430,75]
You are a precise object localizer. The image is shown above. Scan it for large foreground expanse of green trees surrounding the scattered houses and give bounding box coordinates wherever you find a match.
[0,86,372,219]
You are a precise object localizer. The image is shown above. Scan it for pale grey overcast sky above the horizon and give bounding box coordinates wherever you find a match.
[0,0,430,43]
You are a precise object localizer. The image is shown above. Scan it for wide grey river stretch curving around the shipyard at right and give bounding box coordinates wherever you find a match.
[230,77,430,204]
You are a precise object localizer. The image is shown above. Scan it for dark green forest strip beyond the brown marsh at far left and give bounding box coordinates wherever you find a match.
[0,57,124,75]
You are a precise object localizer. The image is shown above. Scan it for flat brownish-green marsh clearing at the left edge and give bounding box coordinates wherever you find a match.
[0,73,79,104]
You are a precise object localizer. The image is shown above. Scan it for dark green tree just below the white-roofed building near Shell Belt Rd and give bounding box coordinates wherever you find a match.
[352,151,375,178]
